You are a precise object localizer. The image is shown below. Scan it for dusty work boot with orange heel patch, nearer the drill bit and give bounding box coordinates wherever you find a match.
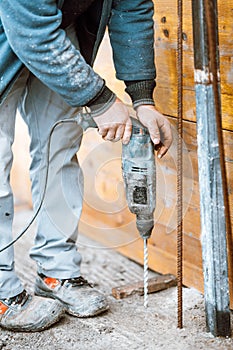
[35,274,108,317]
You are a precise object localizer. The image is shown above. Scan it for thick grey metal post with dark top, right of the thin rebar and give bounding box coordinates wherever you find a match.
[192,0,231,336]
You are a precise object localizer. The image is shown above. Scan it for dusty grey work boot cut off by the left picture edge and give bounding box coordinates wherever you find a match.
[0,290,65,332]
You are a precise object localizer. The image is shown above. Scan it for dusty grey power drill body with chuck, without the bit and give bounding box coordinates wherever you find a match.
[122,118,156,239]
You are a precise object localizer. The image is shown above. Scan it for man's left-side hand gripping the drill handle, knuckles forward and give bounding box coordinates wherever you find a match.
[93,98,132,144]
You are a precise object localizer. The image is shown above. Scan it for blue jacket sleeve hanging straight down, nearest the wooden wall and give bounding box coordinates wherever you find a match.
[109,0,155,81]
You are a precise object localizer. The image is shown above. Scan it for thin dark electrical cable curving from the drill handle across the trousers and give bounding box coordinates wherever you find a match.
[0,119,77,253]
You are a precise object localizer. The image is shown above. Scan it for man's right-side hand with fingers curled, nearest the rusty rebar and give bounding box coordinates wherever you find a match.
[137,105,172,158]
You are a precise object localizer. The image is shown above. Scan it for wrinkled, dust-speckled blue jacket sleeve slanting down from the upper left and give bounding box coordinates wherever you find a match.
[0,0,104,107]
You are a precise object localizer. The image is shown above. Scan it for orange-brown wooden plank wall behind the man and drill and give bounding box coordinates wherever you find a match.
[12,0,233,305]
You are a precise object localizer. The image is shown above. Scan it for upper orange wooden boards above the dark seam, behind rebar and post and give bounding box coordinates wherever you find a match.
[154,0,233,130]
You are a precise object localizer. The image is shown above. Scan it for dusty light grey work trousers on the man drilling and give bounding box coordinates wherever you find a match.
[0,29,83,298]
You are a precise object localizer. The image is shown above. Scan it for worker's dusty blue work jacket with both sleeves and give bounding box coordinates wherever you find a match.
[0,0,155,107]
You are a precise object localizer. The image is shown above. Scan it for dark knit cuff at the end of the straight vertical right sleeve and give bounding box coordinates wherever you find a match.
[125,80,156,108]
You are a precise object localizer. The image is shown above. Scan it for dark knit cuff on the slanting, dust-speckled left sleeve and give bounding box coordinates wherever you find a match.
[86,84,116,117]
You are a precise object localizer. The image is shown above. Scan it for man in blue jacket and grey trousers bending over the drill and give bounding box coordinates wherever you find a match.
[0,0,172,331]
